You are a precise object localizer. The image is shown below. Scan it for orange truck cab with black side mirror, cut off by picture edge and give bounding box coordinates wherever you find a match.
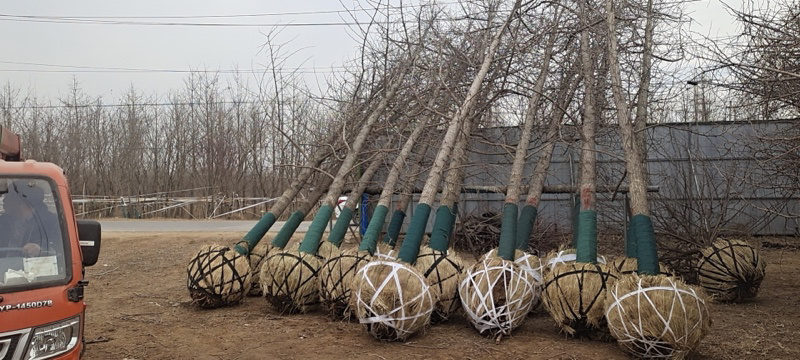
[0,126,100,360]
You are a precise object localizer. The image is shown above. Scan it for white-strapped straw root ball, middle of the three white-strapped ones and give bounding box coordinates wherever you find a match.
[458,257,537,337]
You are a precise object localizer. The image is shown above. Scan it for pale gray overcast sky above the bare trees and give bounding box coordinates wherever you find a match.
[0,0,742,103]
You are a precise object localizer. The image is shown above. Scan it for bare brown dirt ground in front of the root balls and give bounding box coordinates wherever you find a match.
[85,233,800,360]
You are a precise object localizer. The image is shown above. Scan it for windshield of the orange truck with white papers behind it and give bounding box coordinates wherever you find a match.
[0,177,68,292]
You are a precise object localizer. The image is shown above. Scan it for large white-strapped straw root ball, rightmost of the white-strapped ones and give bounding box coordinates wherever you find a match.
[606,275,711,359]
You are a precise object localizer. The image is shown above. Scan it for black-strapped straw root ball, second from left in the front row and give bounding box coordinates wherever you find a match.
[261,250,322,313]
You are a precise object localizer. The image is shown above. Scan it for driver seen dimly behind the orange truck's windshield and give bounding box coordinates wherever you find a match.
[0,180,61,257]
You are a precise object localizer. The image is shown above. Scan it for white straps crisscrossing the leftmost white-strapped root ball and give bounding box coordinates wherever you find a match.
[355,260,434,338]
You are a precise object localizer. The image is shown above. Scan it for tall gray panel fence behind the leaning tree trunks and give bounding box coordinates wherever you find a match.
[376,121,800,235]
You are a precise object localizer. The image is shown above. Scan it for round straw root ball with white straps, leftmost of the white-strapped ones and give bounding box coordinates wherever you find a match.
[353,260,439,341]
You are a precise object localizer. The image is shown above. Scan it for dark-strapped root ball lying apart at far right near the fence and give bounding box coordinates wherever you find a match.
[697,239,767,302]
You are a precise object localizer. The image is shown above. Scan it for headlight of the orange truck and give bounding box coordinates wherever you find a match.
[27,316,81,360]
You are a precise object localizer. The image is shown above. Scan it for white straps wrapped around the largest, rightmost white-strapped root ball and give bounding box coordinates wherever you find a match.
[606,278,705,359]
